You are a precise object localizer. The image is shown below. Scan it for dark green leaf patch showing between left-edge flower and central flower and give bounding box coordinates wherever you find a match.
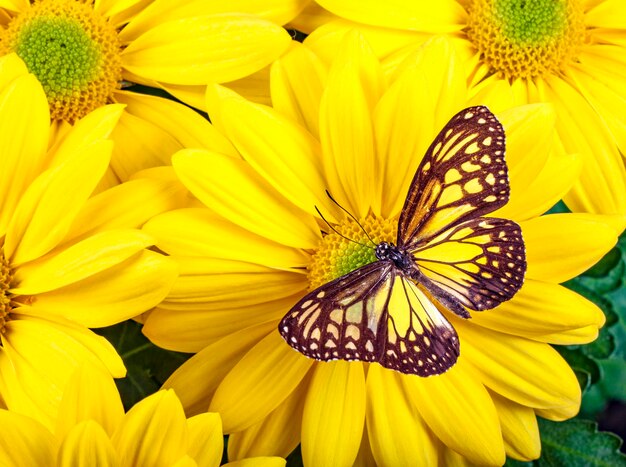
[95,321,191,410]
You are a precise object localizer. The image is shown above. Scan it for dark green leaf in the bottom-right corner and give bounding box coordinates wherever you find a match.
[536,418,626,467]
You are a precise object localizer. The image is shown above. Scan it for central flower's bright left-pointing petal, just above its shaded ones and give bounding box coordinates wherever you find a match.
[143,208,311,269]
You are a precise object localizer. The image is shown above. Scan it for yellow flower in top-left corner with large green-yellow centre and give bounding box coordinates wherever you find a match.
[0,0,308,186]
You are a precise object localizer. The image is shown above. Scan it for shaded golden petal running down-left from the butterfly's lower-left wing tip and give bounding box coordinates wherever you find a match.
[161,317,276,416]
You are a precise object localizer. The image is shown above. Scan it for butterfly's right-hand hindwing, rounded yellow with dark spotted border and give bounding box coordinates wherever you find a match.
[411,217,526,310]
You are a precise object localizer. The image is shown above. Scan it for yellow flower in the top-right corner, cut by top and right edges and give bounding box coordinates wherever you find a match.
[304,0,626,219]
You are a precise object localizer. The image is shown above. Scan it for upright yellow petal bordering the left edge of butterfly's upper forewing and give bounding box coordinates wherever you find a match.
[374,40,466,218]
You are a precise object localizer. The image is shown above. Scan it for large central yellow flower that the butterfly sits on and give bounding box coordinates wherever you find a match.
[144,33,624,466]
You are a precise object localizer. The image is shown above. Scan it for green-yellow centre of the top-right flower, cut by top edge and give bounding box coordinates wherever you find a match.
[466,0,586,80]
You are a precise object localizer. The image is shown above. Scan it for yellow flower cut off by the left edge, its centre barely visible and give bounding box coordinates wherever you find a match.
[0,54,180,436]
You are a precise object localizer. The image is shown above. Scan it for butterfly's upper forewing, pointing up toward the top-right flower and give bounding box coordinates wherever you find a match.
[397,106,509,247]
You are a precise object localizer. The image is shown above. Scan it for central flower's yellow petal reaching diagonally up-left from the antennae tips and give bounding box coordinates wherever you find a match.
[220,93,333,221]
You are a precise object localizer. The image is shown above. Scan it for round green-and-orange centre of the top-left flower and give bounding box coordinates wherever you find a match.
[0,0,122,122]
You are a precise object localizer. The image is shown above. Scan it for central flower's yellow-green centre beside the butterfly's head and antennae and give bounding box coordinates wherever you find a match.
[308,216,398,290]
